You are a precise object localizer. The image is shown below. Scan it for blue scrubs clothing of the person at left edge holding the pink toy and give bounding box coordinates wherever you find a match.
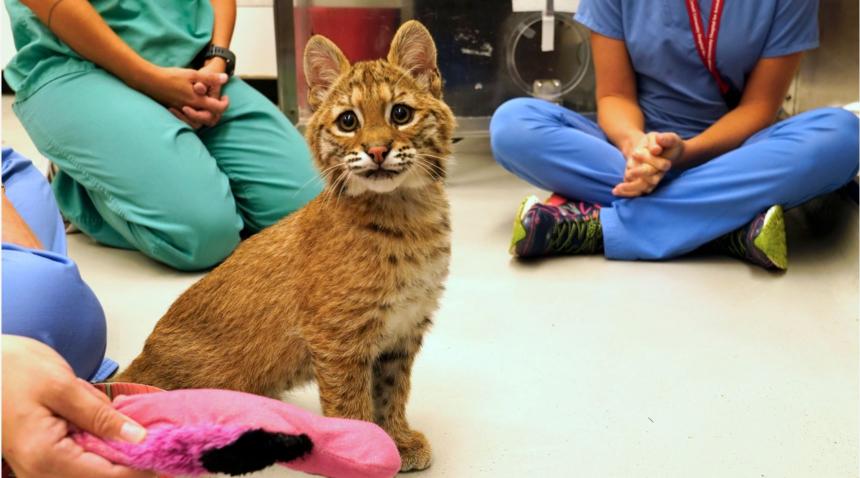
[2,148,117,381]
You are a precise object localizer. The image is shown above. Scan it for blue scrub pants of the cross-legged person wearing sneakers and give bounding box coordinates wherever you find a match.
[490,98,858,260]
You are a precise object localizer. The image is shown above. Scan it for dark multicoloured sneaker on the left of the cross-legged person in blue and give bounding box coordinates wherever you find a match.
[510,195,603,257]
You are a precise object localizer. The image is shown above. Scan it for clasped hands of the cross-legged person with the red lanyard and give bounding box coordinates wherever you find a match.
[612,132,684,198]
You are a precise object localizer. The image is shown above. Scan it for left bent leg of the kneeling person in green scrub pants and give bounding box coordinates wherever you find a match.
[14,70,242,269]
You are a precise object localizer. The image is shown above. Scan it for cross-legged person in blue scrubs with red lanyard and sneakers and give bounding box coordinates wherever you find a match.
[490,0,858,269]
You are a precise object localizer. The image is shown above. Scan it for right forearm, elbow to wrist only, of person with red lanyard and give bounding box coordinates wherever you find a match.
[673,103,776,169]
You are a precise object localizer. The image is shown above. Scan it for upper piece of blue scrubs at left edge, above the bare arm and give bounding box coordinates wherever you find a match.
[3,148,66,255]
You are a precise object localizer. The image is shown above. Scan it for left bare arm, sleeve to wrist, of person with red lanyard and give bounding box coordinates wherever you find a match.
[591,33,645,156]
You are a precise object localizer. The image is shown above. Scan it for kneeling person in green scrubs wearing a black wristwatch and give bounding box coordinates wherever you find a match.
[4,0,322,270]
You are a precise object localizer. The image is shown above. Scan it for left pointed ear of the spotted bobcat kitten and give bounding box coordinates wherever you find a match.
[304,35,349,110]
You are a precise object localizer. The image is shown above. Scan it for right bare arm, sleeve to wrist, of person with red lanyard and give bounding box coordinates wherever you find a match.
[673,53,802,169]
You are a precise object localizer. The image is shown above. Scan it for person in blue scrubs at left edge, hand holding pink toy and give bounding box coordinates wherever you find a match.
[0,148,155,478]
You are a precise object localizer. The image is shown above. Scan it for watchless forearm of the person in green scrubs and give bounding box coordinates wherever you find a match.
[22,0,155,88]
